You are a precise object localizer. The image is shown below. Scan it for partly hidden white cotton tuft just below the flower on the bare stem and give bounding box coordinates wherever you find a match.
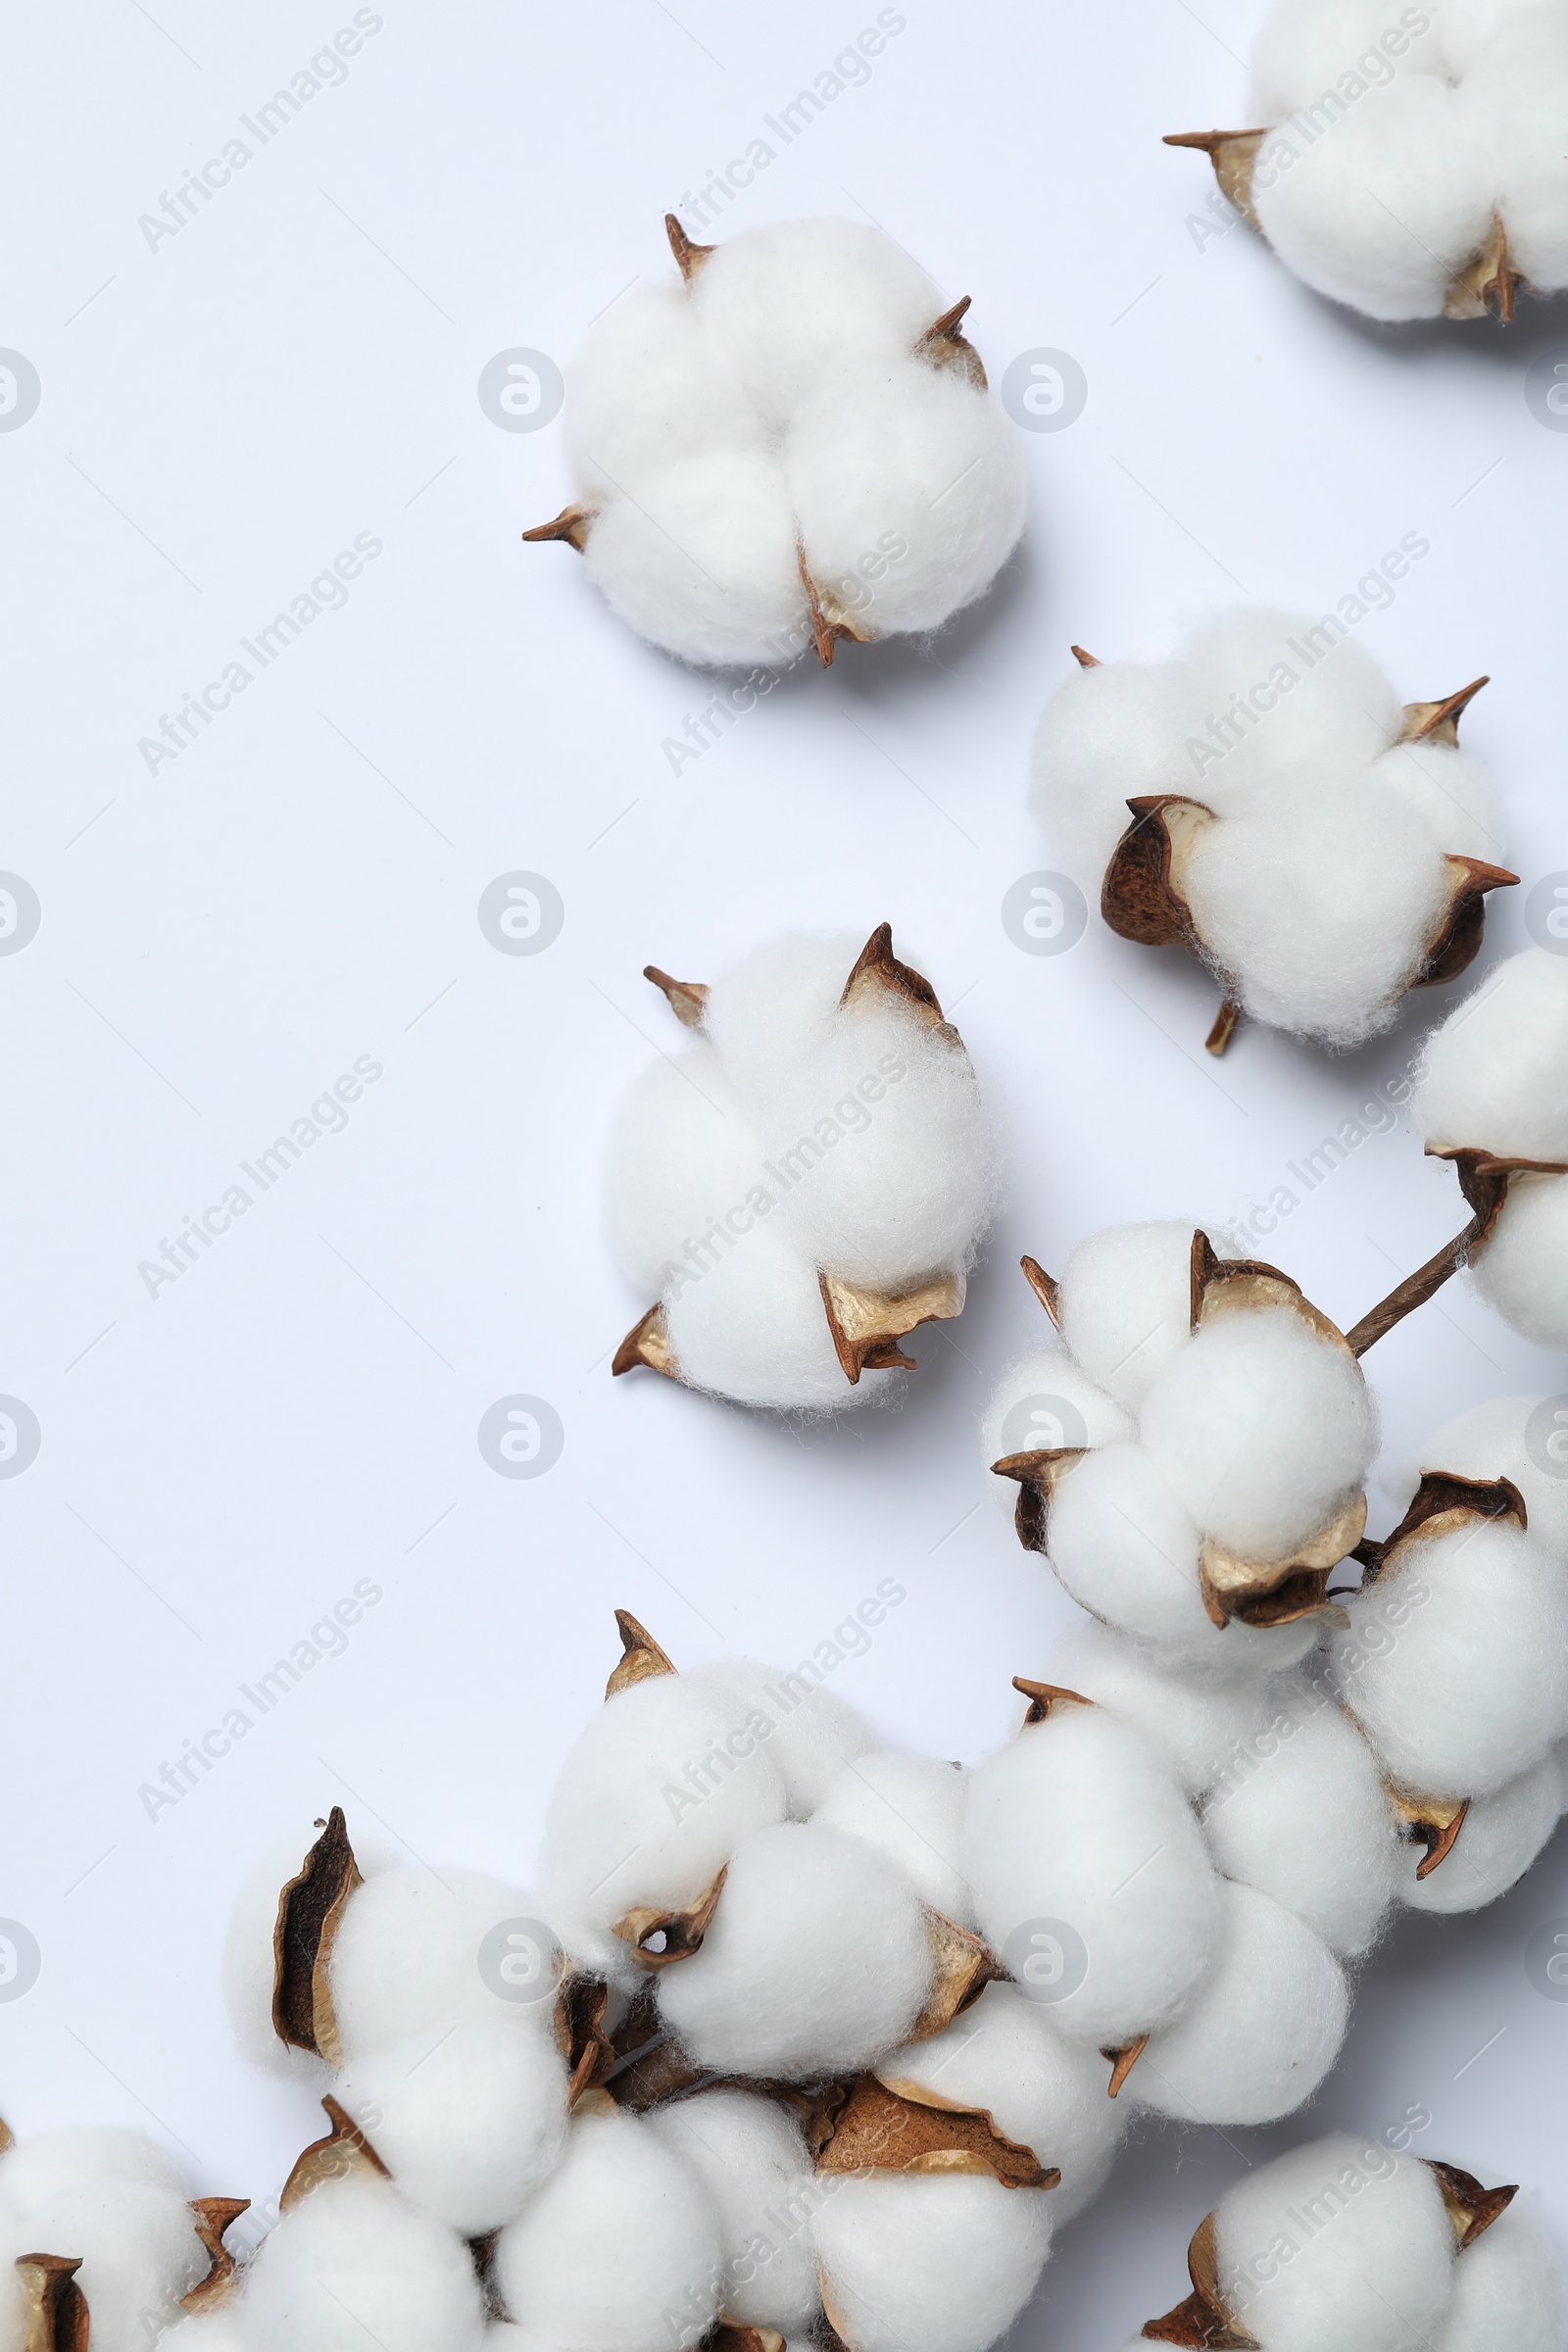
[1051,1625,1277,1797]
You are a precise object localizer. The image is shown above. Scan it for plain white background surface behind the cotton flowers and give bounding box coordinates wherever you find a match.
[0,0,1568,2352]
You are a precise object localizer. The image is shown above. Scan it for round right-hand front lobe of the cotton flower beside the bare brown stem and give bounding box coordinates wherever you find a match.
[1140,1307,1378,1562]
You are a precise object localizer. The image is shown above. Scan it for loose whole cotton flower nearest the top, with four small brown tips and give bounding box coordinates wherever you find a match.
[524,217,1022,663]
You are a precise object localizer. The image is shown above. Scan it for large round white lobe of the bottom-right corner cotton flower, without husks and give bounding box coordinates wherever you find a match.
[1215,2133,1452,2352]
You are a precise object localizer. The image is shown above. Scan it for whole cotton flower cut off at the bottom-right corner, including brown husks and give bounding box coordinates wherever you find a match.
[1126,2133,1568,2352]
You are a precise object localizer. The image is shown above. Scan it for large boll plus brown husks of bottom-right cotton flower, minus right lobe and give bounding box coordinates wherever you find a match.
[1143,2133,1514,2352]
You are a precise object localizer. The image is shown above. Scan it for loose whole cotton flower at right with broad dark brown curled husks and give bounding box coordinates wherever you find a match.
[1032,607,1519,1054]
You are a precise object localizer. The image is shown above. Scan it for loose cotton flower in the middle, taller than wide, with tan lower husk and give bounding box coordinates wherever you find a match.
[607,924,995,1411]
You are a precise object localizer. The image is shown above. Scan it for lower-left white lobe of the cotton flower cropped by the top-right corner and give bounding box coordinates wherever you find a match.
[1253,73,1495,319]
